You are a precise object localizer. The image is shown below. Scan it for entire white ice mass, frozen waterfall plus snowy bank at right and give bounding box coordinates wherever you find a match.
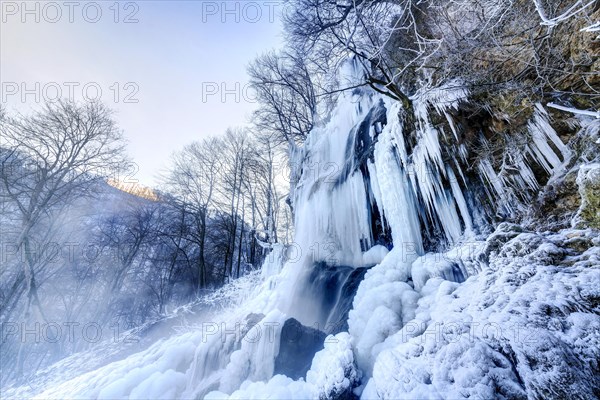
[5,63,600,399]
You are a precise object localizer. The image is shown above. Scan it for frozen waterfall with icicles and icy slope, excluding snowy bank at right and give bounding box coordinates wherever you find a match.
[14,59,569,399]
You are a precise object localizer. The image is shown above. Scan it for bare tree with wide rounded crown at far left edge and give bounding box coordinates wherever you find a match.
[0,101,124,319]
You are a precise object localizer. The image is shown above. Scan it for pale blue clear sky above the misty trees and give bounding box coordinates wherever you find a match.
[0,0,282,185]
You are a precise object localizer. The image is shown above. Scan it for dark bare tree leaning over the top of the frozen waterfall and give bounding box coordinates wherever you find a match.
[284,0,414,107]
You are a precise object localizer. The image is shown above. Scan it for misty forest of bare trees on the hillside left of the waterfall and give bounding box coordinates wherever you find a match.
[0,101,289,380]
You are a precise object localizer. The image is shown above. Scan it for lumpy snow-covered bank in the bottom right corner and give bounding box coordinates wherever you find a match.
[363,228,600,399]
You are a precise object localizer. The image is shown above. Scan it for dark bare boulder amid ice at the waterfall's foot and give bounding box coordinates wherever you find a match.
[273,318,326,379]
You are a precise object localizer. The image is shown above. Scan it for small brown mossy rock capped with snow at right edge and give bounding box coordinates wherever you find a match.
[575,164,600,228]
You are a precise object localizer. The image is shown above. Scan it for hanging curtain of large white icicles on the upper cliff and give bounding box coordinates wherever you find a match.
[292,63,570,260]
